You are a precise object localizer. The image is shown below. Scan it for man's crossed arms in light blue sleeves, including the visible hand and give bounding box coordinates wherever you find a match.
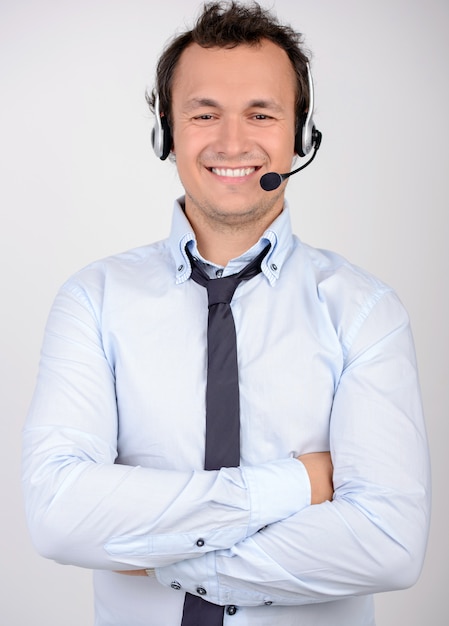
[24,268,429,605]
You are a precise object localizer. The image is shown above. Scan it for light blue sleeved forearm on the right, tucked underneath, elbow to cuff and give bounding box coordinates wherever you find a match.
[156,448,429,606]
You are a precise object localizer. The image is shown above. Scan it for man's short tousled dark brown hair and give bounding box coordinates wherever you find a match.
[146,2,309,125]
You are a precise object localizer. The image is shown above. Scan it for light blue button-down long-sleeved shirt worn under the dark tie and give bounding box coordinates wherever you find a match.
[23,202,430,626]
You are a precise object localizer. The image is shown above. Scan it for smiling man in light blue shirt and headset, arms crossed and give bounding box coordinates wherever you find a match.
[24,3,429,626]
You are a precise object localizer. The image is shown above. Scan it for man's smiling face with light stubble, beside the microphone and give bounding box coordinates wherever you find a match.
[172,40,296,234]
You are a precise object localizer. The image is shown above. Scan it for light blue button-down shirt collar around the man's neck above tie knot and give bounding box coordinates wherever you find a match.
[169,197,293,285]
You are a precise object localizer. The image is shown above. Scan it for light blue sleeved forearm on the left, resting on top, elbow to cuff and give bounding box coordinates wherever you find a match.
[24,422,310,569]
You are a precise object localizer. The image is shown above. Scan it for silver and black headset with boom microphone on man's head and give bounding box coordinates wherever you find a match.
[151,63,322,191]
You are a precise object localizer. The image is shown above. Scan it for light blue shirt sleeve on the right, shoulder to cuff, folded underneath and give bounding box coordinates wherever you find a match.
[157,292,430,606]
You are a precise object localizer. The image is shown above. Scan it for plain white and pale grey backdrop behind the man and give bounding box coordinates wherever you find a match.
[0,0,449,626]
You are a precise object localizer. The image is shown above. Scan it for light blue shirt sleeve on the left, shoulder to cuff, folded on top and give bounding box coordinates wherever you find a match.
[23,285,310,569]
